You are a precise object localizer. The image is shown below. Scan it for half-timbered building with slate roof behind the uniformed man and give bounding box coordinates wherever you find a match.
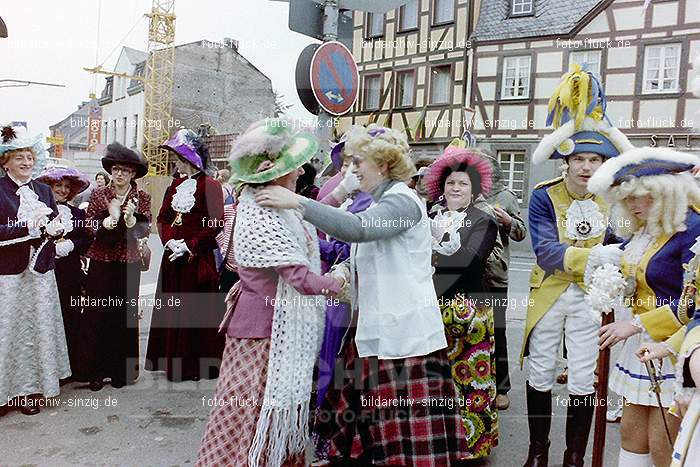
[470,0,700,202]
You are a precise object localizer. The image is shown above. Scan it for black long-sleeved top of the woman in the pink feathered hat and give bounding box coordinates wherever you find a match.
[433,205,498,299]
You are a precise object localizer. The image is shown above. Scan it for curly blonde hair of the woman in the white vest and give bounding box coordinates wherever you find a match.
[345,123,416,182]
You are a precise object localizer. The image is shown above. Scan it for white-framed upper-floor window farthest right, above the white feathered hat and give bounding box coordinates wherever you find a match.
[642,44,681,94]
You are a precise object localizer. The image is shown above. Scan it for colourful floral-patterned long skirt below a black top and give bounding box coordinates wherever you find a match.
[440,299,498,459]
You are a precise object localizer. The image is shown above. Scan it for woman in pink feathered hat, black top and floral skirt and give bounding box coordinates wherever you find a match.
[425,146,498,459]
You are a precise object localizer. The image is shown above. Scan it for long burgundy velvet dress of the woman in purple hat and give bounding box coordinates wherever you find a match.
[146,173,226,380]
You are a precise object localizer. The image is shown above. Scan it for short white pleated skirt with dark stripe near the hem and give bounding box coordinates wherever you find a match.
[608,330,676,407]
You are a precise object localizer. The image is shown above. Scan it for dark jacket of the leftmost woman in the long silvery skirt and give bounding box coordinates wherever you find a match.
[0,176,58,276]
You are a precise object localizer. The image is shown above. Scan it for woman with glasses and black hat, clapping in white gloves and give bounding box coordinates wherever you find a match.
[82,143,151,391]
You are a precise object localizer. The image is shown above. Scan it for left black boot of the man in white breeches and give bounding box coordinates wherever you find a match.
[524,383,552,467]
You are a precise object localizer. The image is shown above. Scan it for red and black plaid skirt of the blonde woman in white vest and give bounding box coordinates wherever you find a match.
[315,339,468,467]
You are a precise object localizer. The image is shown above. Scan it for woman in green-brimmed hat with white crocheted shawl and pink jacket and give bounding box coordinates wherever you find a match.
[197,119,343,467]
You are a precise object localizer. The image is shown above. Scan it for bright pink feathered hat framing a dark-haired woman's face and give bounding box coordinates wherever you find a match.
[423,146,493,200]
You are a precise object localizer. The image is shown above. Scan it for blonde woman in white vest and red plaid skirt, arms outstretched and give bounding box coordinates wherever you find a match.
[257,125,468,466]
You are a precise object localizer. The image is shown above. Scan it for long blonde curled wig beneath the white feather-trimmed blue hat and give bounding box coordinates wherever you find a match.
[606,172,700,238]
